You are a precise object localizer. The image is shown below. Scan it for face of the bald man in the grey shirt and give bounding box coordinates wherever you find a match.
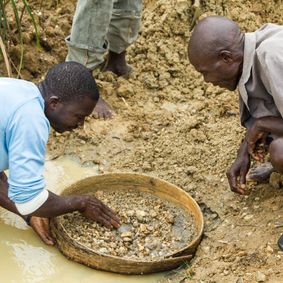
[190,51,241,90]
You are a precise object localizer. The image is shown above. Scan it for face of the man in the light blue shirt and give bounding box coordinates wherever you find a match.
[45,96,97,133]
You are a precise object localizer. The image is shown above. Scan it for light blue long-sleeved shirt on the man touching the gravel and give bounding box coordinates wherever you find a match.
[0,78,50,211]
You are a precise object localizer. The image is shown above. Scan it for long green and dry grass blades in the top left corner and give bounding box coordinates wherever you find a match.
[0,0,40,77]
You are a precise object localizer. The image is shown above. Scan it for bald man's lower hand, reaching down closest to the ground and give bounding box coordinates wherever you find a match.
[226,141,250,195]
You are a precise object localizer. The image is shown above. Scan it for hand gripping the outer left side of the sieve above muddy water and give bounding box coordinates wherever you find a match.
[30,216,55,246]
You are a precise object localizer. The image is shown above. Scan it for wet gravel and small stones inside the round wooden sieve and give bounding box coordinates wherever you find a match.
[60,190,196,261]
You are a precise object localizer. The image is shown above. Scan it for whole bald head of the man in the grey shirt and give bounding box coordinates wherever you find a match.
[188,16,244,90]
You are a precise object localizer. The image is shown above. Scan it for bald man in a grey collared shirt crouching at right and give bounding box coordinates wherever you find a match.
[188,16,283,249]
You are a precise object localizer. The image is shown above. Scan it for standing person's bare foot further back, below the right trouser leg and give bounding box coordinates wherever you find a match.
[103,51,133,77]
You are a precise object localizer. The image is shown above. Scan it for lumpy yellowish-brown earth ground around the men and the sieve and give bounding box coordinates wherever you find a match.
[2,0,283,283]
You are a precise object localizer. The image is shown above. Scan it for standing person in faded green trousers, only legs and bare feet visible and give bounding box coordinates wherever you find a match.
[66,0,142,119]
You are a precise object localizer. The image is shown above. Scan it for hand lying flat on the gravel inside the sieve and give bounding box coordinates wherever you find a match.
[81,196,120,228]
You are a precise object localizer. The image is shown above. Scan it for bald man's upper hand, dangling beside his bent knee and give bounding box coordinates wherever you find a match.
[246,119,268,162]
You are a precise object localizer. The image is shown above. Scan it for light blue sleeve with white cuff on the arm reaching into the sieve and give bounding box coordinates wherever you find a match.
[6,99,50,214]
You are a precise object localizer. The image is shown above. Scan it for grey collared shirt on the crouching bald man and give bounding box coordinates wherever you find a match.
[238,24,283,126]
